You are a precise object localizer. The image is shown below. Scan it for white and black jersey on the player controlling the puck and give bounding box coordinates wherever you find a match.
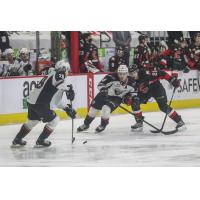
[28,72,69,108]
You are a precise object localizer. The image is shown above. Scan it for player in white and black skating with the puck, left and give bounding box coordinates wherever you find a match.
[12,60,76,147]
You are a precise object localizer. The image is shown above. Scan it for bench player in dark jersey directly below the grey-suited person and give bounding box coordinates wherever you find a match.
[109,46,125,72]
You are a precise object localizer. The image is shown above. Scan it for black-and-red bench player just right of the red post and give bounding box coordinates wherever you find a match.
[81,33,103,73]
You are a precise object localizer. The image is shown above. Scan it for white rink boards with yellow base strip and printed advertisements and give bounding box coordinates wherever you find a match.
[0,70,200,125]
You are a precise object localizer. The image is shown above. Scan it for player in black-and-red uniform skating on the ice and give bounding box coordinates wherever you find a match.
[127,65,185,131]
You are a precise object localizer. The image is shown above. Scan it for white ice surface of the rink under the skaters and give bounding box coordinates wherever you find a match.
[0,108,200,167]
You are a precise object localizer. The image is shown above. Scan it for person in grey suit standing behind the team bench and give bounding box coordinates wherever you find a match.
[112,31,131,66]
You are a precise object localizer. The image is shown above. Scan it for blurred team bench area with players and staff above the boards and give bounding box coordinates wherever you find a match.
[0,31,200,77]
